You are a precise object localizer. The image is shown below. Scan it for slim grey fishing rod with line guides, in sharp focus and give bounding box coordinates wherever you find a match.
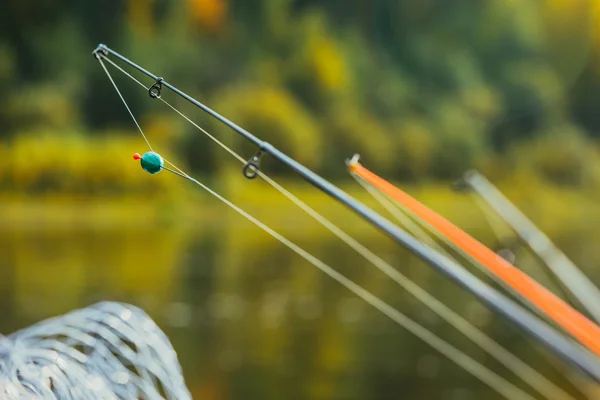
[93,44,600,382]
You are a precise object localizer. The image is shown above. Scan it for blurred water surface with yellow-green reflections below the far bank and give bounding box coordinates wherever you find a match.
[0,214,592,399]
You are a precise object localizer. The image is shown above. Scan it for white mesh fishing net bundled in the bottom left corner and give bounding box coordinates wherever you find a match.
[0,302,191,400]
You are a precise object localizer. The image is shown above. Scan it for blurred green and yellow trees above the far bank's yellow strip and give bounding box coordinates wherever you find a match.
[0,0,600,193]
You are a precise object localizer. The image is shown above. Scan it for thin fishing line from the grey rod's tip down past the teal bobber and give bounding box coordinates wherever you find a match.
[98,56,536,399]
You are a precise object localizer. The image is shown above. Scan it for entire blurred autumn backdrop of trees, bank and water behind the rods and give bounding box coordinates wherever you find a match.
[0,0,600,400]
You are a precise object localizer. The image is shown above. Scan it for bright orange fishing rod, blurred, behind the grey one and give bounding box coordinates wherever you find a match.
[348,160,600,356]
